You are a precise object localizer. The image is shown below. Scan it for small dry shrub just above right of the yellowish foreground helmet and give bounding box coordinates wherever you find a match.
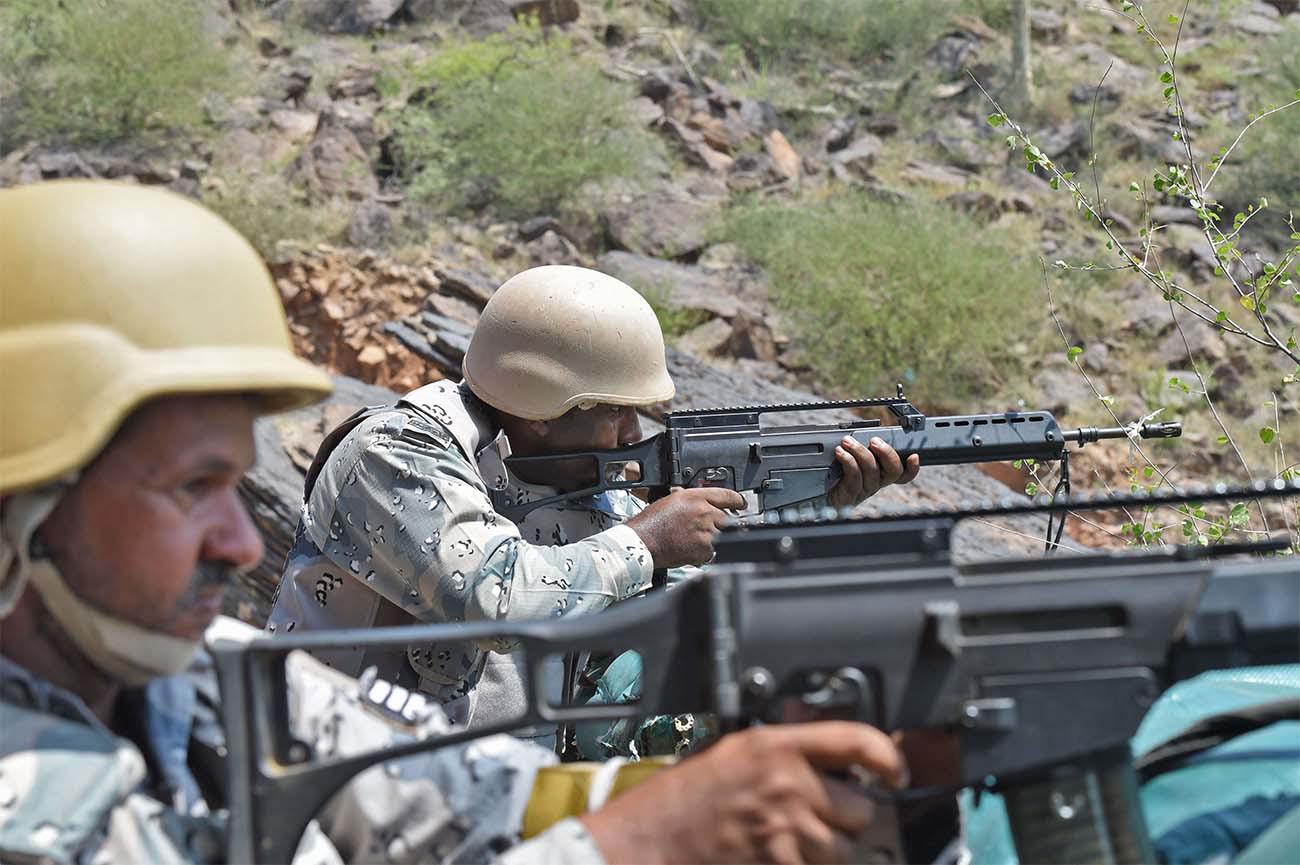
[203,172,347,261]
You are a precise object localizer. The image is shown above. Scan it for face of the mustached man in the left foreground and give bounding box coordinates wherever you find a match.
[40,397,263,640]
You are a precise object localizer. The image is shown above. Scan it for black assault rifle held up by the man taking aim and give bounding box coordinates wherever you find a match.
[494,385,1183,520]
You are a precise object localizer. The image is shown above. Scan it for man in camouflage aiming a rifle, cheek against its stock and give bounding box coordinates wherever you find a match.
[268,265,918,757]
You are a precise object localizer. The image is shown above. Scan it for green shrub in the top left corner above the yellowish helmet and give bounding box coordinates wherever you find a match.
[0,0,233,142]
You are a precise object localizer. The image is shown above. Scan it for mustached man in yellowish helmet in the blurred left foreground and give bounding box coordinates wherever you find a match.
[0,181,901,862]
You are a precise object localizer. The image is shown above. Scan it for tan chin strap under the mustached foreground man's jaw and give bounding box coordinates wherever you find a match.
[27,558,202,687]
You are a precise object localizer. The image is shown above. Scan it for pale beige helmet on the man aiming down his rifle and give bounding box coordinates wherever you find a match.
[464,264,673,420]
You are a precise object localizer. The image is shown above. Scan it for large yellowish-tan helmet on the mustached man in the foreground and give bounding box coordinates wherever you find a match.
[0,181,332,493]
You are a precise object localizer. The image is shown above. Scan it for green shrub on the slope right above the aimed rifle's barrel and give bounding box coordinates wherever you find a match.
[724,194,1041,407]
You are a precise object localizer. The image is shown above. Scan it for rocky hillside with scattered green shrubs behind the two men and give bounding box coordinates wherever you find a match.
[0,0,1300,582]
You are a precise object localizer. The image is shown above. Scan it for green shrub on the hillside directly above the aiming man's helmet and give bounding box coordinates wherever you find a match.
[394,26,654,216]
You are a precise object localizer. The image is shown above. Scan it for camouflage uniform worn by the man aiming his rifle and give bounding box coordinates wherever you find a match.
[268,381,696,757]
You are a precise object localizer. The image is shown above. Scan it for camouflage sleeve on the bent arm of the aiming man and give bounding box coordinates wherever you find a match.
[308,411,654,639]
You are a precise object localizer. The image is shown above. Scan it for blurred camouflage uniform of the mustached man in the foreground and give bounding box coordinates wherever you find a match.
[0,616,601,865]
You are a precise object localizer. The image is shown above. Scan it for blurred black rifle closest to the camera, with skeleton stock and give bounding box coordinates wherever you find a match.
[212,481,1300,862]
